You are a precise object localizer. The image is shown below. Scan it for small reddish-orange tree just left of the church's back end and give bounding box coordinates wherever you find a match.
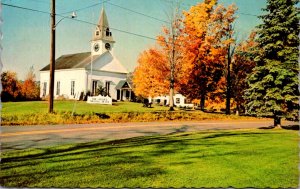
[21,67,40,100]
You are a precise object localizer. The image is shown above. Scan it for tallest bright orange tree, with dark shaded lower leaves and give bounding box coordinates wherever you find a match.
[180,0,236,109]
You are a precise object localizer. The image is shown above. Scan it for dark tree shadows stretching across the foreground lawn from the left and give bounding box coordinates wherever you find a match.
[0,130,290,187]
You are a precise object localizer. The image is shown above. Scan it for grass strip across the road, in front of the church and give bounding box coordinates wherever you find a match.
[1,101,262,125]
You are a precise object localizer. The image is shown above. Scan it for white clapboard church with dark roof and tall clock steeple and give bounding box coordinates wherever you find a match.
[40,9,133,100]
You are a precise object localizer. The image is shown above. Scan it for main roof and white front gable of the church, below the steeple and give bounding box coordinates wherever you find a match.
[40,51,128,73]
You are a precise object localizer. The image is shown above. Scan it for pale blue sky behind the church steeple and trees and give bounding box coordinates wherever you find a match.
[0,0,266,80]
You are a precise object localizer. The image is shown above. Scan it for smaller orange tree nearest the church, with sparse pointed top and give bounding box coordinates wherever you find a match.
[133,5,182,103]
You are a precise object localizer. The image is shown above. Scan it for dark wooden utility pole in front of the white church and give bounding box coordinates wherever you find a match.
[48,0,55,113]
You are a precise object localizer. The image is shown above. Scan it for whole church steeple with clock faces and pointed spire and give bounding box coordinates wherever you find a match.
[91,8,115,55]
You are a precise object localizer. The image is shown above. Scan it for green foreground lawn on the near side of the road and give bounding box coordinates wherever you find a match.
[0,130,299,188]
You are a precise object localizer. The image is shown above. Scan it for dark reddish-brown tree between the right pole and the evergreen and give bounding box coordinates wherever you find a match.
[231,32,258,114]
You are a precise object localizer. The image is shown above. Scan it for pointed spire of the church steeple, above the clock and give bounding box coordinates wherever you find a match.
[93,7,114,42]
